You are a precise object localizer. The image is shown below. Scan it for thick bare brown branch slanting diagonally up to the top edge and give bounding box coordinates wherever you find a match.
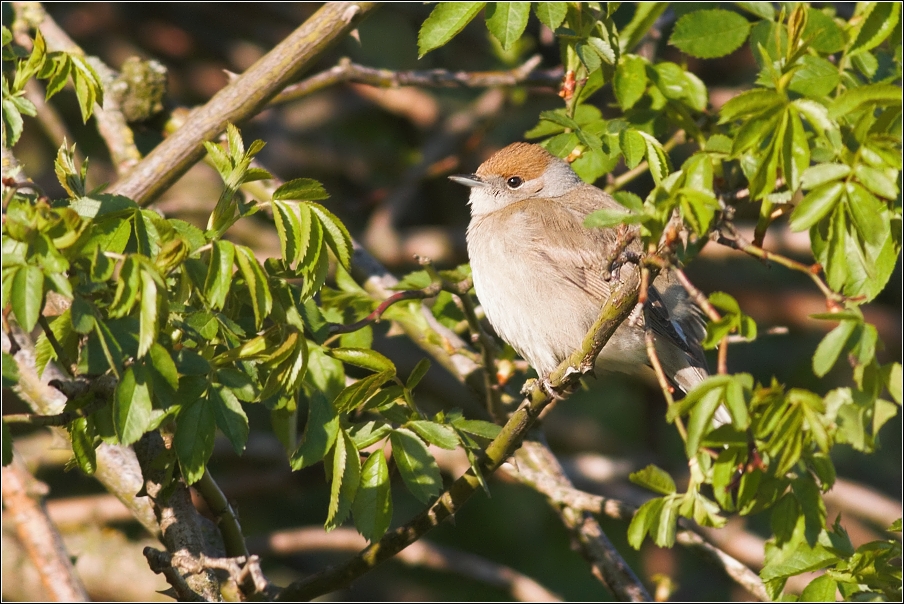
[110,2,376,205]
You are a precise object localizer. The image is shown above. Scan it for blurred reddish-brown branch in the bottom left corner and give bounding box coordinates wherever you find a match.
[2,458,88,602]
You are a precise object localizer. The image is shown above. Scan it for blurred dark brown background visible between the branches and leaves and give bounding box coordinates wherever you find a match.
[3,3,902,601]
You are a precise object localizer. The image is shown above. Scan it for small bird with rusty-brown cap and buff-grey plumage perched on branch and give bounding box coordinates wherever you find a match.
[450,143,707,392]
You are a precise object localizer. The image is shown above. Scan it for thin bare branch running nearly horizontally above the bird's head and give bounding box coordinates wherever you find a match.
[270,55,562,105]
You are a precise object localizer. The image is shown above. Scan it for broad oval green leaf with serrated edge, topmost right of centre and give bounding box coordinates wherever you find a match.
[669,9,750,59]
